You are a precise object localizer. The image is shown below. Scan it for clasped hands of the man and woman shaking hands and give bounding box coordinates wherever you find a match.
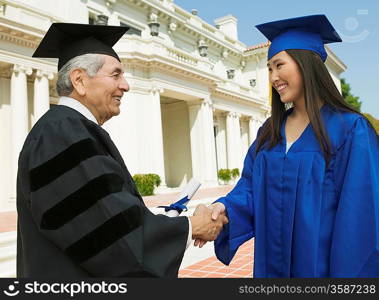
[189,202,228,248]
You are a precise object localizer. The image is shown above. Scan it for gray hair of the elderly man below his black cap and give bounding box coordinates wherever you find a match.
[57,53,104,96]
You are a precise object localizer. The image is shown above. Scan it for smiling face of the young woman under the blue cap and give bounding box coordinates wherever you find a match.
[267,51,304,103]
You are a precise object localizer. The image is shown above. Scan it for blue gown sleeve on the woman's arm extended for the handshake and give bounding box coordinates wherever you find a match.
[214,143,255,265]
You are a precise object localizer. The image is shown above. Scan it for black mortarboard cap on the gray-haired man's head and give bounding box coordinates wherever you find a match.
[33,23,129,70]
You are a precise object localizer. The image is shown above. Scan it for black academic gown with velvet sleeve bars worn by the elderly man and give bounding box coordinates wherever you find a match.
[17,106,188,278]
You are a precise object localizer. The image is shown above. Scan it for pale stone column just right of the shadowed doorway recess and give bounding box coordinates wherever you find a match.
[188,98,217,186]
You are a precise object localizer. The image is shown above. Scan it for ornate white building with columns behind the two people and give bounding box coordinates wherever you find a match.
[0,0,346,211]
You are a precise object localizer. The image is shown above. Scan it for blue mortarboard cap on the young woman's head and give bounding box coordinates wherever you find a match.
[256,15,342,62]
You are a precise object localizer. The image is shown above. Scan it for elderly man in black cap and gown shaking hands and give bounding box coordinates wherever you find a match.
[17,23,227,278]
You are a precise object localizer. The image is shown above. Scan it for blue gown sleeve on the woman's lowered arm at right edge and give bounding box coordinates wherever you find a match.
[330,118,379,277]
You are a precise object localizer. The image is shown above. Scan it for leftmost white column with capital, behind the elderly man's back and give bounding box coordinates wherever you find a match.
[10,65,32,201]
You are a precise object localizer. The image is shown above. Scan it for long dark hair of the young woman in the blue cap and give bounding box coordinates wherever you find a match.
[256,49,366,164]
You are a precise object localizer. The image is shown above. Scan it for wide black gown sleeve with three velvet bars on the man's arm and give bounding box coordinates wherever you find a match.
[20,118,188,277]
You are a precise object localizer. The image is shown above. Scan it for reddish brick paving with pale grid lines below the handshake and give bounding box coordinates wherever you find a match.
[179,240,254,278]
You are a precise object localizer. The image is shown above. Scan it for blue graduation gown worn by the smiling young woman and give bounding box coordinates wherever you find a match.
[215,105,379,277]
